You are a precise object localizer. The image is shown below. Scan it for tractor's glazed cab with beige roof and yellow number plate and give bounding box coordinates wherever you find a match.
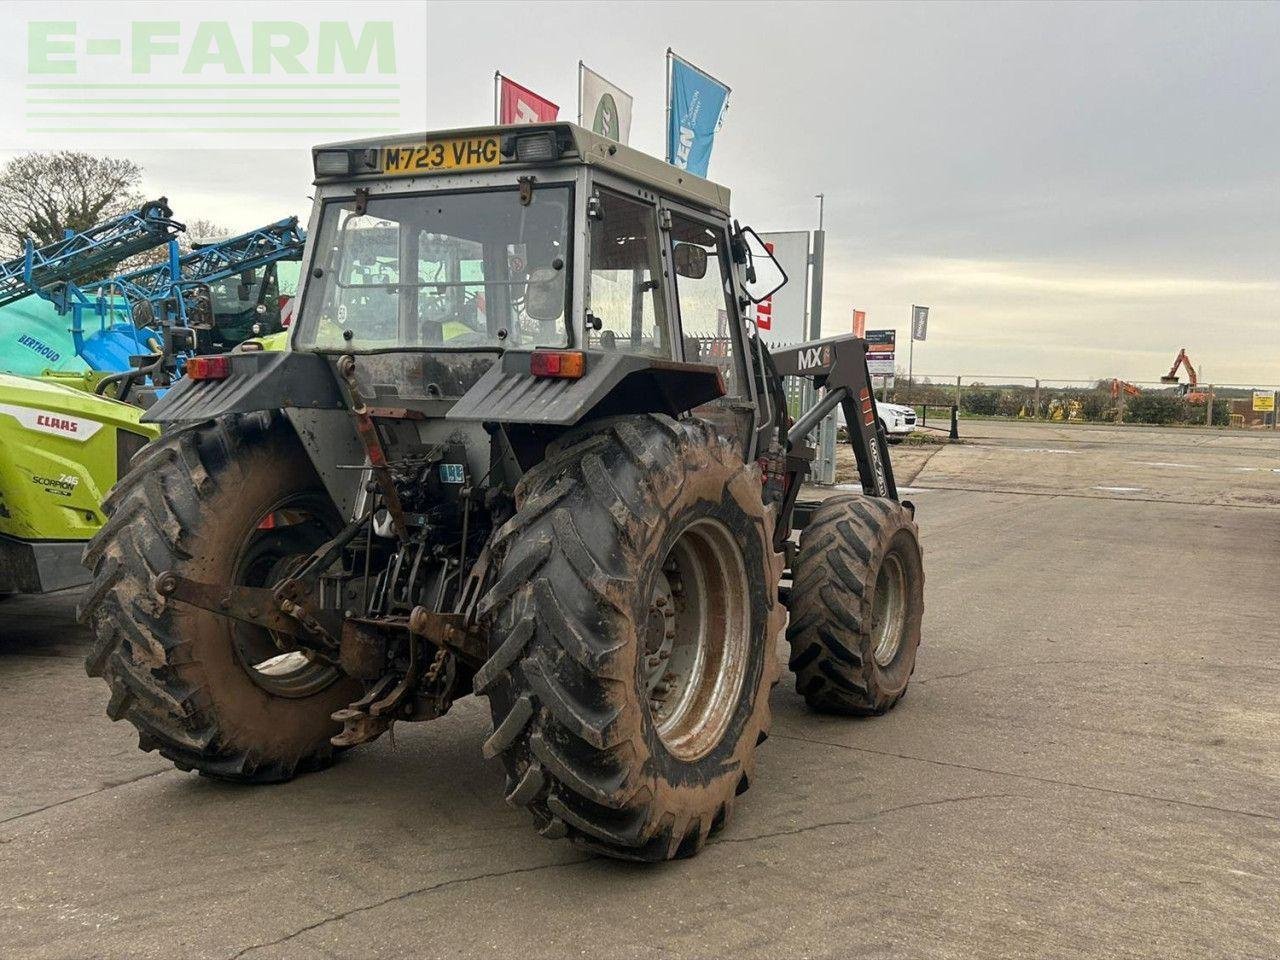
[292,123,786,458]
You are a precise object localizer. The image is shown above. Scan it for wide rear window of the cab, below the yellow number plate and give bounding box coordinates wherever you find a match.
[297,187,571,352]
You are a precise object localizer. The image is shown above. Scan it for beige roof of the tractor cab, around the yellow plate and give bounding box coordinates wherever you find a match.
[311,123,730,214]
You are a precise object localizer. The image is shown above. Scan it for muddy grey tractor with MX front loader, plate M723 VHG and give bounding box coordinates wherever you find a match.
[81,123,923,860]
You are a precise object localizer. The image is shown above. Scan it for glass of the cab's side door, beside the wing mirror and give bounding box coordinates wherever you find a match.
[671,211,742,394]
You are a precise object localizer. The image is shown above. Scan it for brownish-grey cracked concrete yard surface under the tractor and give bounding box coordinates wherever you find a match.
[0,422,1280,960]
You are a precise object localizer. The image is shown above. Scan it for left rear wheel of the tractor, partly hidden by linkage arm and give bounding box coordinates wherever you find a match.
[79,415,361,782]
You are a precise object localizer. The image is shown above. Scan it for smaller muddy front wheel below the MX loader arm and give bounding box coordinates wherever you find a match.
[787,494,924,716]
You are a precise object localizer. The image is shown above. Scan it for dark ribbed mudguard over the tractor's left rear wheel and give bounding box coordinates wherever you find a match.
[142,351,346,424]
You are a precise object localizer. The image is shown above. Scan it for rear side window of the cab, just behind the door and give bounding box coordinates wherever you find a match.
[586,189,672,357]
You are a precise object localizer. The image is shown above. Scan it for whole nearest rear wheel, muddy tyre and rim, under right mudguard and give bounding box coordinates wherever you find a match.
[475,416,782,860]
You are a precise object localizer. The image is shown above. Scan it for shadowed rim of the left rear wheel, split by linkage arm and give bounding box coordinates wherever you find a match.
[230,494,342,698]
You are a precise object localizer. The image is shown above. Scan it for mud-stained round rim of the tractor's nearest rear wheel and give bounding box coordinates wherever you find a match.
[643,520,751,762]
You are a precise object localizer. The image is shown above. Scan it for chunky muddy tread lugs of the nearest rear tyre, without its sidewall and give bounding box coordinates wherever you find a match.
[475,415,783,860]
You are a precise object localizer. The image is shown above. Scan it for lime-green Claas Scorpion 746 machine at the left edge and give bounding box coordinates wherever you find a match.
[0,374,160,595]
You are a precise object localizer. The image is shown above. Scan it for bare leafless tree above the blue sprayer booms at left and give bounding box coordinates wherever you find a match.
[0,150,142,256]
